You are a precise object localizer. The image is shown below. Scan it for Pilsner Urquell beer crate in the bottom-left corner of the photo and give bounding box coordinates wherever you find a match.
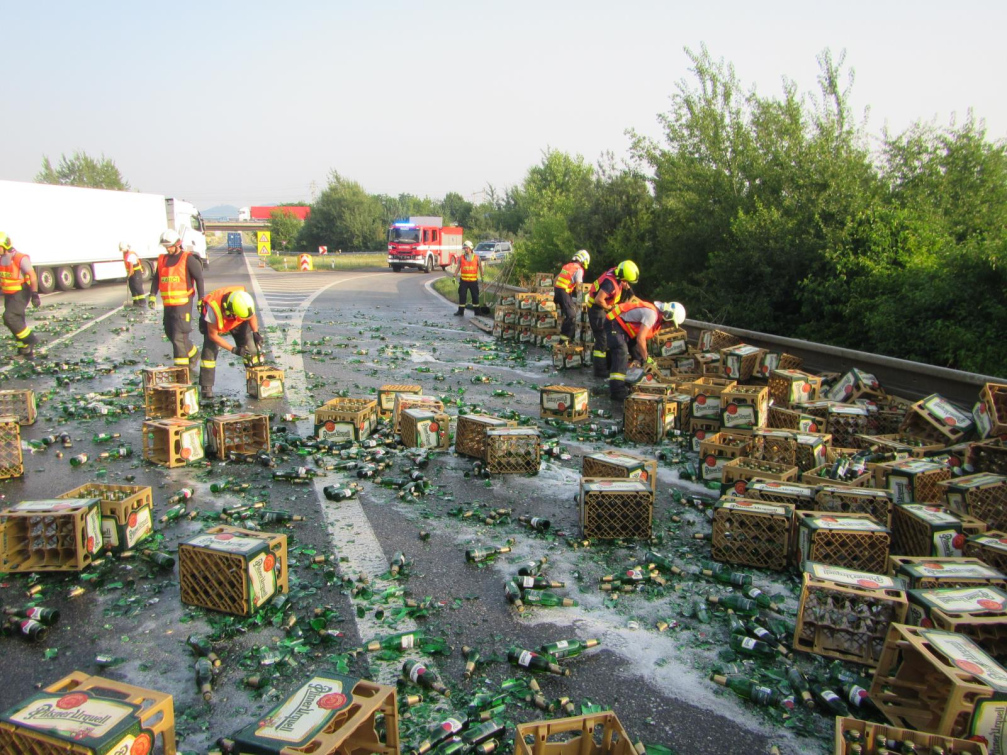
[0,671,175,755]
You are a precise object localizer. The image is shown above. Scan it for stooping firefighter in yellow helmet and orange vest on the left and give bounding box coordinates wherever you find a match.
[199,286,262,399]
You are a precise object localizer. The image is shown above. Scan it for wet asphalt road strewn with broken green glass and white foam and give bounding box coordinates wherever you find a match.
[0,254,828,755]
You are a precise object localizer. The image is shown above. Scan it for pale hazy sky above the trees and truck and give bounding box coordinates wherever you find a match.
[7,0,1007,208]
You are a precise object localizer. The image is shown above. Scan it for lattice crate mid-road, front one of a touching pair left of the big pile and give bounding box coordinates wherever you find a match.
[580,477,654,540]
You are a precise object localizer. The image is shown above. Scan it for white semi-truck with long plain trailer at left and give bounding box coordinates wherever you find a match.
[0,181,206,293]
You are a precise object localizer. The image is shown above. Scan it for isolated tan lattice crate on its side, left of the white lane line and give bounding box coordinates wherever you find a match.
[178,526,289,616]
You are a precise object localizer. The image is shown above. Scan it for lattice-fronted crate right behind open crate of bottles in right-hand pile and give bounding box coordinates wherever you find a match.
[795,511,891,574]
